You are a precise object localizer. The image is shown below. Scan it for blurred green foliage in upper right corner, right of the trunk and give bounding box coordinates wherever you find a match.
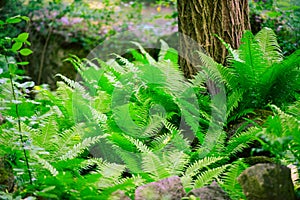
[249,0,300,56]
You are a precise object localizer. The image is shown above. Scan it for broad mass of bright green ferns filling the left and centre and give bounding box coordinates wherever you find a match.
[0,29,266,199]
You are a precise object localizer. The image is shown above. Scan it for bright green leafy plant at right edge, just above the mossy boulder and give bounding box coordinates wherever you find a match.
[258,101,300,164]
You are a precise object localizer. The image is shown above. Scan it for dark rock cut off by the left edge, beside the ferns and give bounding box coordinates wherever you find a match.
[0,158,14,192]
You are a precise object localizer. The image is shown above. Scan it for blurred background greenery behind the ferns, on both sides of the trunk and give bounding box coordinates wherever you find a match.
[0,0,300,87]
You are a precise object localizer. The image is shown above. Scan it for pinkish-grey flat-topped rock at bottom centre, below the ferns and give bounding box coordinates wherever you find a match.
[135,176,185,200]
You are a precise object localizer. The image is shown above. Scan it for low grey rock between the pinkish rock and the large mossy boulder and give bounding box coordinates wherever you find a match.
[188,182,230,200]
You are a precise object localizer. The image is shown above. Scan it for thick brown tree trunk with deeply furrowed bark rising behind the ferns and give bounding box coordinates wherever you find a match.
[177,0,250,78]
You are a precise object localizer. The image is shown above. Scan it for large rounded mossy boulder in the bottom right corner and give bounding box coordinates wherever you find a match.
[238,163,295,200]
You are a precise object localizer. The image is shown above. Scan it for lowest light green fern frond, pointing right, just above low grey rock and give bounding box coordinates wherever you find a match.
[193,165,230,188]
